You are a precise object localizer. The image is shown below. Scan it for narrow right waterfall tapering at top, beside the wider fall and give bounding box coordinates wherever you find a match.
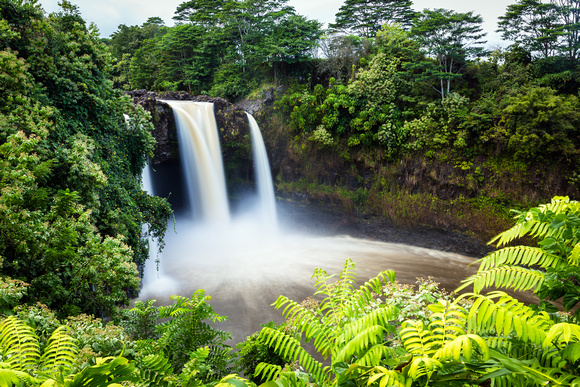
[246,113,278,228]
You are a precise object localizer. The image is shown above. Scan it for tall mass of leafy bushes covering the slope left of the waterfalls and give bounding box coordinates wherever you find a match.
[0,0,171,315]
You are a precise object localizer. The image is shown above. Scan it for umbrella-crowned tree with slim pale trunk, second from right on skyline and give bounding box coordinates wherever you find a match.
[411,8,485,101]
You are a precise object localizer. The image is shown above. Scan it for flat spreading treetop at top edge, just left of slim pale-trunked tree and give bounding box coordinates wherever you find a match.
[329,0,414,38]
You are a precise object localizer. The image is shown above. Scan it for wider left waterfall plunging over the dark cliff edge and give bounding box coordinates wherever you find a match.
[164,100,230,223]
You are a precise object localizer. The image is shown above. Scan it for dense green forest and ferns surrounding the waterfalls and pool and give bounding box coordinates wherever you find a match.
[0,0,580,387]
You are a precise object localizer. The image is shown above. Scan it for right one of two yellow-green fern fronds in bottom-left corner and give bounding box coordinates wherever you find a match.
[39,325,79,375]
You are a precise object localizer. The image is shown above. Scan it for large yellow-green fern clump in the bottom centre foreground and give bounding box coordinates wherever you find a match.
[256,260,396,384]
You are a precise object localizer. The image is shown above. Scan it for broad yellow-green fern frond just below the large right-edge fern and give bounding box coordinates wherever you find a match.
[460,291,553,345]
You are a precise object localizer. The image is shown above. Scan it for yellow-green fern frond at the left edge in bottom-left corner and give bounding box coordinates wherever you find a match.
[0,316,40,371]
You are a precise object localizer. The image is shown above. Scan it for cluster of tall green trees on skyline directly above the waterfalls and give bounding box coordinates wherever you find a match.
[111,0,321,99]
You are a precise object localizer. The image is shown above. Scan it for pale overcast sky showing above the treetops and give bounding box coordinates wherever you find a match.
[39,0,515,46]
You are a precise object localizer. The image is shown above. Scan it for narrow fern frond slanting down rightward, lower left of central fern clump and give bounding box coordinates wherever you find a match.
[258,327,330,383]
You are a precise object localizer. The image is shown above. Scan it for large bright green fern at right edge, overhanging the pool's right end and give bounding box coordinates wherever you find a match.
[459,197,580,320]
